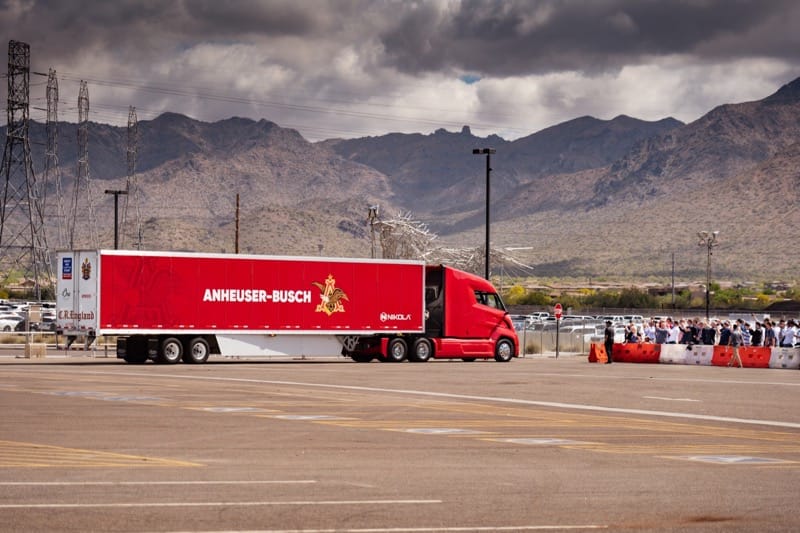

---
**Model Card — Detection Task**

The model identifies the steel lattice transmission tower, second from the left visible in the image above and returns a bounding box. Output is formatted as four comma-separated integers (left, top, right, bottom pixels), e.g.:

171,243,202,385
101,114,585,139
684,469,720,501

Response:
42,69,67,249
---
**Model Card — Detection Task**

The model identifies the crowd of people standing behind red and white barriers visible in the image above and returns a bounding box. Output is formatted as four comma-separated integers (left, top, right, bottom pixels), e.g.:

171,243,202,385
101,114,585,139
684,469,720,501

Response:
625,317,800,348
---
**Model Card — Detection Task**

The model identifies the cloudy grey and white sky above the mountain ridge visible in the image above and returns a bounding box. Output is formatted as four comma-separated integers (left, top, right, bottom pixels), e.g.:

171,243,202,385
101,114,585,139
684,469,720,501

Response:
0,0,800,140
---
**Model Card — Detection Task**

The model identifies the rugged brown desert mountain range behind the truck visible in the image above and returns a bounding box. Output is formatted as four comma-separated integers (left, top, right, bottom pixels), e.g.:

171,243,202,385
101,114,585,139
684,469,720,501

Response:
3,78,800,281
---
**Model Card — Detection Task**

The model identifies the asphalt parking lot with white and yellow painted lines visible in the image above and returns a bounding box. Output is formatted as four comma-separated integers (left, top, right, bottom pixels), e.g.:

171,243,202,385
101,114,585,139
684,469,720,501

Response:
0,355,800,532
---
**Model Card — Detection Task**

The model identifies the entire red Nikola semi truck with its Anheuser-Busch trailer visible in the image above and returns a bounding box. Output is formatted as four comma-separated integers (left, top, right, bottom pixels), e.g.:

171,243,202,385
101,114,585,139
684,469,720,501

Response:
56,250,519,363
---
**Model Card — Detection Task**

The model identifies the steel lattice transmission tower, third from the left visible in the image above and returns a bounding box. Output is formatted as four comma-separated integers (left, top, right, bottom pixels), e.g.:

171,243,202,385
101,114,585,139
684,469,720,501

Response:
67,80,97,249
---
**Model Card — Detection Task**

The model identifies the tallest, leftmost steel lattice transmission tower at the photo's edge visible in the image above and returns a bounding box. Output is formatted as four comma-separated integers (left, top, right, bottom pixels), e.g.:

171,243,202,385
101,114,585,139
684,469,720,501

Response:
0,41,53,300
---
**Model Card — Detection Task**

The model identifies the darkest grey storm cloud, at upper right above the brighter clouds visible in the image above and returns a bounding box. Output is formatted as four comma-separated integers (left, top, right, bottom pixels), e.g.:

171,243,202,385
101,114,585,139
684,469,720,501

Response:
382,0,800,76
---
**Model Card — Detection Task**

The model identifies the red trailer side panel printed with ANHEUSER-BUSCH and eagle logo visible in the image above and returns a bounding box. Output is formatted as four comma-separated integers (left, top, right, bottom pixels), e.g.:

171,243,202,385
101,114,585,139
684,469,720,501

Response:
99,251,425,334
